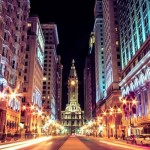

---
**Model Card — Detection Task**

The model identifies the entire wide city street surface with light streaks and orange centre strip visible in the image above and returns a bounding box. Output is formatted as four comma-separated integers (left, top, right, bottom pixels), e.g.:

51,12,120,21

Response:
0,136,149,150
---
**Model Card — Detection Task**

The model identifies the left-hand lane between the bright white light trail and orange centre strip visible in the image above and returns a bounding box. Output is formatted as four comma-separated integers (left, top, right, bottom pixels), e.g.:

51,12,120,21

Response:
20,136,68,150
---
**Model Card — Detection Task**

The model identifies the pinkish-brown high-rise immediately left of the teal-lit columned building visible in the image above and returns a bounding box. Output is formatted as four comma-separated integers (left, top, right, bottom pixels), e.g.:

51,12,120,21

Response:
103,0,121,137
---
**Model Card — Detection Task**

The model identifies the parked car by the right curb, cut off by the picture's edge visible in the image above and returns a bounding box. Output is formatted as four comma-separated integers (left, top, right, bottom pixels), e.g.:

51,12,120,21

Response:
126,135,150,145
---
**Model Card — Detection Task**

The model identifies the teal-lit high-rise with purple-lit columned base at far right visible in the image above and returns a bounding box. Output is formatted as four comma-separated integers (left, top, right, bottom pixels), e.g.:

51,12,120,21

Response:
118,0,150,135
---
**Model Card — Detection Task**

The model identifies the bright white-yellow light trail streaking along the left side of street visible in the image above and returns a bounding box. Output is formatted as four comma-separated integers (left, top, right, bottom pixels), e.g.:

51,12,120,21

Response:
0,137,52,150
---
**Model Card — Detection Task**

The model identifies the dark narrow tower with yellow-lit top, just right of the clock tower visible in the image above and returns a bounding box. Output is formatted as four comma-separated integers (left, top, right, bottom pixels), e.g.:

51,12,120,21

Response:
84,32,96,120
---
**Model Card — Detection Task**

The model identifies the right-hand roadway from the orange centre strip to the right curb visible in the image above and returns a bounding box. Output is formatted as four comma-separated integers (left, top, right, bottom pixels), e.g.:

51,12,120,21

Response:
79,137,149,150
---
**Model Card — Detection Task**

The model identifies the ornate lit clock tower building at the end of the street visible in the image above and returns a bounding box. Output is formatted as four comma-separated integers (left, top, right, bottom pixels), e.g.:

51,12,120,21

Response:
62,60,84,134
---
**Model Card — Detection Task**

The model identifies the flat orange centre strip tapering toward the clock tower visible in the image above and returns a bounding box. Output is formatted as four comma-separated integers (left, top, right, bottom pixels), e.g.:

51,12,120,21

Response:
59,136,90,150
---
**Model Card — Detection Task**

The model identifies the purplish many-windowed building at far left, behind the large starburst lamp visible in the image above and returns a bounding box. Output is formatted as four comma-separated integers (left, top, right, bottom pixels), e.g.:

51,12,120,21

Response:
0,0,30,137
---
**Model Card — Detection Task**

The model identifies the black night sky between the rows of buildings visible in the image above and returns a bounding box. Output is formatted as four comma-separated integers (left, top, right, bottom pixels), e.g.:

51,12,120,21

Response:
30,0,95,110
